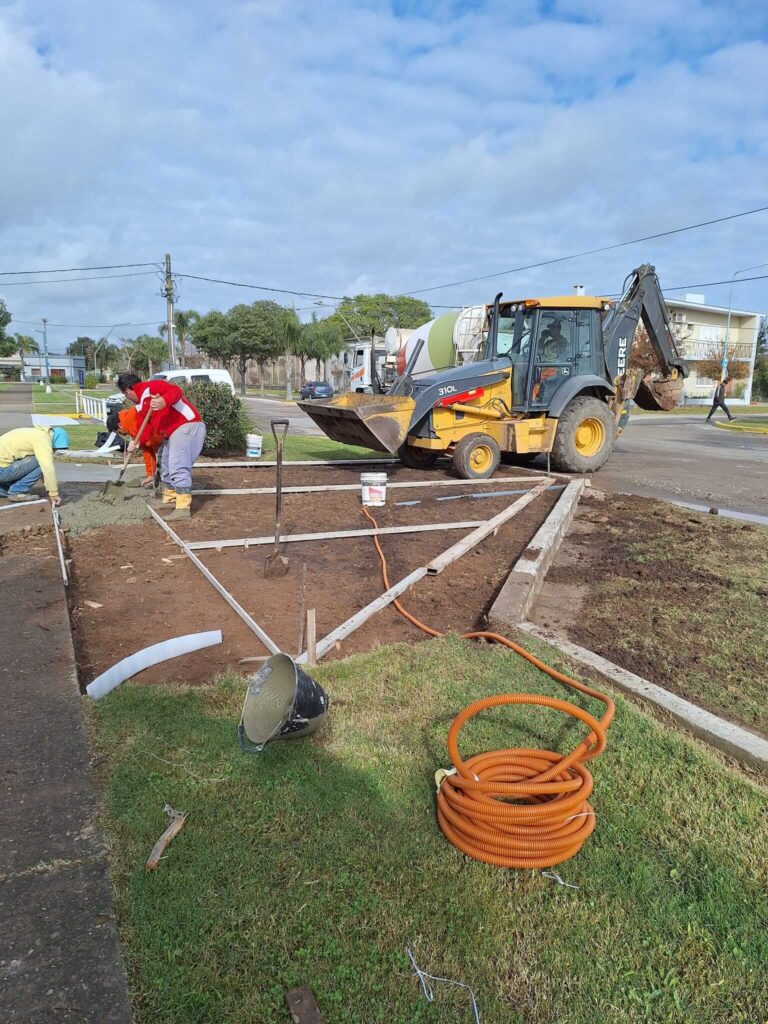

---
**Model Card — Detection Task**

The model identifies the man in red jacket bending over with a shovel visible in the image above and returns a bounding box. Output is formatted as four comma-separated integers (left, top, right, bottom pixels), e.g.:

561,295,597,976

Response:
118,374,206,522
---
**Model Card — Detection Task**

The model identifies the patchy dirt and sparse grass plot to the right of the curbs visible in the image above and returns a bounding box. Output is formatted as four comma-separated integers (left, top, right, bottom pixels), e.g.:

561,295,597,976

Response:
530,492,768,733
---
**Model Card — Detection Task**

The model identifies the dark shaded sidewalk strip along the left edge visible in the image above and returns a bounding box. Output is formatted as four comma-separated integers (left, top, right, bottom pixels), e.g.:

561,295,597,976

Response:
0,506,131,1024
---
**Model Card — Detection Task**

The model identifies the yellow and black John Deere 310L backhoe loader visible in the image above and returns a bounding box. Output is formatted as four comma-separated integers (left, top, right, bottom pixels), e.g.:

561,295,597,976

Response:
299,264,688,479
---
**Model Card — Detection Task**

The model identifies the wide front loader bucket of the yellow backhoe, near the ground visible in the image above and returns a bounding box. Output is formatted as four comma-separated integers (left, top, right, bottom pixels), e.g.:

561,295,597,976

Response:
297,392,416,452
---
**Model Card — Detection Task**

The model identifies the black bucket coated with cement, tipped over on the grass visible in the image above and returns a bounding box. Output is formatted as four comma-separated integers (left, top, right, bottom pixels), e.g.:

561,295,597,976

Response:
238,654,328,752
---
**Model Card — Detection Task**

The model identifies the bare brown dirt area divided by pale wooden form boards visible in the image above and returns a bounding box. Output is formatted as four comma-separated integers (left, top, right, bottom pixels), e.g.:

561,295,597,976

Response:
68,467,560,686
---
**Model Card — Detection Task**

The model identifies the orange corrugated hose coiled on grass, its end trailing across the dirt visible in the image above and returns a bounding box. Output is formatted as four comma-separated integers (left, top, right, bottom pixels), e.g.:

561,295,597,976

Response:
362,506,615,868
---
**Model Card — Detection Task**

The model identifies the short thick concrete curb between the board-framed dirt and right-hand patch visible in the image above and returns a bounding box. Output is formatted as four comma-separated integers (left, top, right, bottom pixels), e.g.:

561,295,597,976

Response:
488,479,587,630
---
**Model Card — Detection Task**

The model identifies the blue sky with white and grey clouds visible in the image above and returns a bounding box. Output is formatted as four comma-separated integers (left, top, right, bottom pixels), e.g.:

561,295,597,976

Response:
0,0,768,349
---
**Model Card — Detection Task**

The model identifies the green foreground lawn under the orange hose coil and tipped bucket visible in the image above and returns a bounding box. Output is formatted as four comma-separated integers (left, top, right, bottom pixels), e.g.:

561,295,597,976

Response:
88,638,768,1024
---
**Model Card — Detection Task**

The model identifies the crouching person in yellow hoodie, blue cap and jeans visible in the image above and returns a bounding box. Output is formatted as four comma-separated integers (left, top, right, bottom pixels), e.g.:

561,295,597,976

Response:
0,427,70,505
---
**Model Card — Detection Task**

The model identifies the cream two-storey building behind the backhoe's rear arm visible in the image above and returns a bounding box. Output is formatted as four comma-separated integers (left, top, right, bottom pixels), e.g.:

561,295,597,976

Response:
665,295,763,406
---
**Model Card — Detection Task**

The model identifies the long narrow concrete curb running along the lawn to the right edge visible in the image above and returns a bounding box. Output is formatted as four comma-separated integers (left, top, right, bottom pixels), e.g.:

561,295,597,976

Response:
517,623,768,769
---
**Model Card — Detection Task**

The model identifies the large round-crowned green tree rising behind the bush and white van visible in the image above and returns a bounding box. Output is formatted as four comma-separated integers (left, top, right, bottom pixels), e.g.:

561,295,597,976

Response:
191,299,288,394
